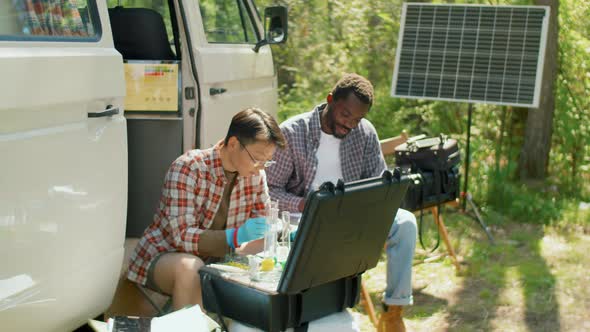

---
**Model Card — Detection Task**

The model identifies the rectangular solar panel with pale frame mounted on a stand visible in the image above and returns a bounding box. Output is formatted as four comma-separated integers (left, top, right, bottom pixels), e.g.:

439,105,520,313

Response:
391,3,549,107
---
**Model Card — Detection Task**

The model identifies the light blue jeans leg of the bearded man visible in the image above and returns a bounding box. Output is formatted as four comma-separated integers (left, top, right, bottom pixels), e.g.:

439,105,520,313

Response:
383,209,417,305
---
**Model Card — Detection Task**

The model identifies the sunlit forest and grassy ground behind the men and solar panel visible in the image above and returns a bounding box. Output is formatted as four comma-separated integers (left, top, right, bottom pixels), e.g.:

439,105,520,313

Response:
108,0,590,332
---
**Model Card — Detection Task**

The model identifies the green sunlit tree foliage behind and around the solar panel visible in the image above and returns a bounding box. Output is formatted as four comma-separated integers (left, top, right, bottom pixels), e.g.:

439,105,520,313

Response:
264,0,590,223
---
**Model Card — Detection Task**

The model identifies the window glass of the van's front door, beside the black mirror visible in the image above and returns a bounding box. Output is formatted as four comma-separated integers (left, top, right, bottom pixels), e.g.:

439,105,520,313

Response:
199,0,258,44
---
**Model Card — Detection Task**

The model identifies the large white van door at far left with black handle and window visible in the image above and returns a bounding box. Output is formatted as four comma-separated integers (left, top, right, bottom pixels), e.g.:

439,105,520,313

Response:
0,0,127,331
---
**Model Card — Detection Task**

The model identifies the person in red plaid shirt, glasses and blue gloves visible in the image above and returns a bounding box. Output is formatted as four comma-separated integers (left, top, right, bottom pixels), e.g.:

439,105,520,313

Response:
127,108,285,310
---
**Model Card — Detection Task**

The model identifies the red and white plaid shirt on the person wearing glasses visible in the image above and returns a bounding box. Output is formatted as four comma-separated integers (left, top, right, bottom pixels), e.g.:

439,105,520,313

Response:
127,144,268,285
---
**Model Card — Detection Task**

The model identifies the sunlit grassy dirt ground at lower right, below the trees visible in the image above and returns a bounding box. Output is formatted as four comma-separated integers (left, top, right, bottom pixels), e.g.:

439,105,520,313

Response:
354,213,590,332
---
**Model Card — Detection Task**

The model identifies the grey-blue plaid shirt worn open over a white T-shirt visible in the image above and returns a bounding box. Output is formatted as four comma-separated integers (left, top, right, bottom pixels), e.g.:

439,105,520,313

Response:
266,104,387,211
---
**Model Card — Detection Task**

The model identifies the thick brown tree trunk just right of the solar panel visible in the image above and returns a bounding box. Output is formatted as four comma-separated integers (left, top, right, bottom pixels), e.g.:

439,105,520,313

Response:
518,0,559,181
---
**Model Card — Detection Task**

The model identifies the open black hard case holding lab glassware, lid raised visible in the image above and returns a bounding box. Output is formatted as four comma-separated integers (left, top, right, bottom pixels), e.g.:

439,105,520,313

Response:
199,170,410,331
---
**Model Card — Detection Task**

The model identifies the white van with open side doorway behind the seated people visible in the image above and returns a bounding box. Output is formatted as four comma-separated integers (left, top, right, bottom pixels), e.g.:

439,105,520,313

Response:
0,0,287,331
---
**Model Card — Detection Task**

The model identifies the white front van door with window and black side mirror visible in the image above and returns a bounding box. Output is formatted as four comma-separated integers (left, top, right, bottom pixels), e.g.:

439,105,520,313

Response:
180,0,286,148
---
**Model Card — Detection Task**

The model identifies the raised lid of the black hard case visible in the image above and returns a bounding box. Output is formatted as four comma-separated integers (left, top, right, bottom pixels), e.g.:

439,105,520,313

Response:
278,170,410,294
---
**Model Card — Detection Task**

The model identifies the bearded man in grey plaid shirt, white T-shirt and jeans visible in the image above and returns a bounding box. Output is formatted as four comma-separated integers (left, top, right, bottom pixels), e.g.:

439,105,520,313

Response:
267,74,416,331
